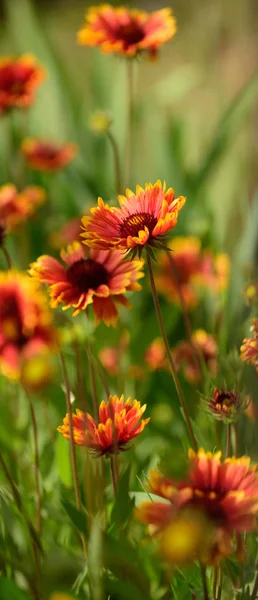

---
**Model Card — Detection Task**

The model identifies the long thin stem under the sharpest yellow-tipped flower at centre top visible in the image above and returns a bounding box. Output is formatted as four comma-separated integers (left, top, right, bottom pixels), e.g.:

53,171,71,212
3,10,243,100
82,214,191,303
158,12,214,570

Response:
147,254,197,451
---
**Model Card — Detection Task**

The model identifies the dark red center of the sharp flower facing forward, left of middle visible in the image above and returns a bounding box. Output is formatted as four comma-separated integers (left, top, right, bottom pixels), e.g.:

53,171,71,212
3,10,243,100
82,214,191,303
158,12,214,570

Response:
66,258,109,292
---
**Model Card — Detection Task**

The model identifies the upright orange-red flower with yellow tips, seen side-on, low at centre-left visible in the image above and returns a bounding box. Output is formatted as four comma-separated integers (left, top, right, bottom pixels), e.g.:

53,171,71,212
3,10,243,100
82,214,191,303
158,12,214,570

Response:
57,395,150,456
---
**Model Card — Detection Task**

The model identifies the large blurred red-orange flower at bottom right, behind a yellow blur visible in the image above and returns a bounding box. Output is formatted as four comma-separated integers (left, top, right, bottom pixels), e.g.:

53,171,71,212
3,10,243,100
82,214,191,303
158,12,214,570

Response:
137,448,258,563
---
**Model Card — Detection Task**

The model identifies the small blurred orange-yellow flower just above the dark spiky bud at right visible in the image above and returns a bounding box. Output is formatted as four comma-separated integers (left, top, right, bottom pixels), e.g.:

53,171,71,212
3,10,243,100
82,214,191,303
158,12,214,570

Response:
172,329,218,383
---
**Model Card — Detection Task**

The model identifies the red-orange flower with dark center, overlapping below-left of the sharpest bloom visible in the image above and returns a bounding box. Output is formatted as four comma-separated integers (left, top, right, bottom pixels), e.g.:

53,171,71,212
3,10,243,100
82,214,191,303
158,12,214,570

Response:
29,242,143,325
